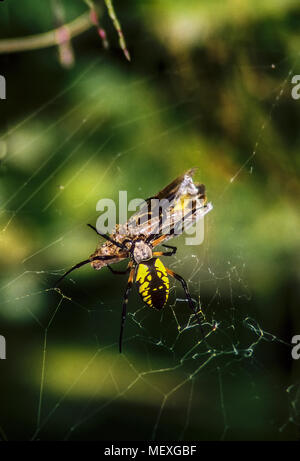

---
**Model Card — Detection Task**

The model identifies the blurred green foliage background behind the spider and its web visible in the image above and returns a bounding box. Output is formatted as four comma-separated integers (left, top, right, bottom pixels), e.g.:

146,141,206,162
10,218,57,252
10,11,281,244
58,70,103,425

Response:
0,0,300,440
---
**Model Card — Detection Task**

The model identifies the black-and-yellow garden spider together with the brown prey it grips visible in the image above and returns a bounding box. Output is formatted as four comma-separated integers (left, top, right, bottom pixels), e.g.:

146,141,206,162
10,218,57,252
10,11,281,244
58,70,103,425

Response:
57,169,212,352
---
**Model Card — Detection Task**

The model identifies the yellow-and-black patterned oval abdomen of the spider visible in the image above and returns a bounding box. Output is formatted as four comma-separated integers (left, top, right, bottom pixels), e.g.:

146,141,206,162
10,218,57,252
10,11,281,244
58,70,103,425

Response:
136,258,170,310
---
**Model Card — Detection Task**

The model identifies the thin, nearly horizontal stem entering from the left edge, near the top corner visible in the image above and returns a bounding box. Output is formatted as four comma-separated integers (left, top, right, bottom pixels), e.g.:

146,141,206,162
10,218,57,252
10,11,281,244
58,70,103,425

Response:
0,12,93,54
